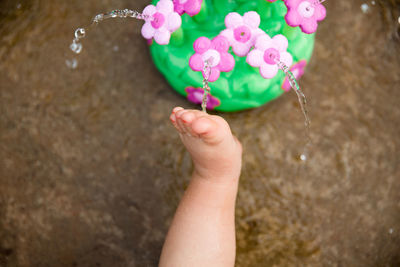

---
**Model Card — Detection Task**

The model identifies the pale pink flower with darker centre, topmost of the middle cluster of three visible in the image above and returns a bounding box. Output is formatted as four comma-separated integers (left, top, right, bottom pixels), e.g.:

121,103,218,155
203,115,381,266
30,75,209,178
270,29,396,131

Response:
221,11,264,57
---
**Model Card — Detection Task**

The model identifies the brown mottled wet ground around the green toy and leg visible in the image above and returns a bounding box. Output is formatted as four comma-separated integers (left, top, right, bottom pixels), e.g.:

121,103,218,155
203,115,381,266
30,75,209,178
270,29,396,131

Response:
0,0,400,266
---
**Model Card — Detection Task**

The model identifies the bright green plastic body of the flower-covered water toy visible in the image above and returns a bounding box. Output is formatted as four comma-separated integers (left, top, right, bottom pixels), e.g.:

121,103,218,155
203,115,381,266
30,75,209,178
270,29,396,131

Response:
150,0,314,112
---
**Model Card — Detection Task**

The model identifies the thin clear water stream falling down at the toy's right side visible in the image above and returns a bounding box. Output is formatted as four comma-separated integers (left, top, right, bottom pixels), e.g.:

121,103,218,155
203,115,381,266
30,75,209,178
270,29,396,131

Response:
276,60,311,161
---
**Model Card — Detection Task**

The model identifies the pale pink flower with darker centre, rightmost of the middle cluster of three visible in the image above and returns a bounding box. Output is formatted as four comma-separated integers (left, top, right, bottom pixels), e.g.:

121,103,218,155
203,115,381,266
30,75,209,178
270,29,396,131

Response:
246,34,293,79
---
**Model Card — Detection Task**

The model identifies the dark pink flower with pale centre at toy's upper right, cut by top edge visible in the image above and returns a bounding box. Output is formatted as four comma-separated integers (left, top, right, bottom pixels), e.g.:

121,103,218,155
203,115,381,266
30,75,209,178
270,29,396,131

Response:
285,0,326,33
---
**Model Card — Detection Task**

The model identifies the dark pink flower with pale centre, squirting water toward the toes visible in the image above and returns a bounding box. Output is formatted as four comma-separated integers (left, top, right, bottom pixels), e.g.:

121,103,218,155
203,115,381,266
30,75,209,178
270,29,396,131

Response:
189,35,235,82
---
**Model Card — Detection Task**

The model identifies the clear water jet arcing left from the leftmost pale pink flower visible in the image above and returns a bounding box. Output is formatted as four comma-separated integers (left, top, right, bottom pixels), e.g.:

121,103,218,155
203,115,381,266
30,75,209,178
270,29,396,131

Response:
69,9,153,54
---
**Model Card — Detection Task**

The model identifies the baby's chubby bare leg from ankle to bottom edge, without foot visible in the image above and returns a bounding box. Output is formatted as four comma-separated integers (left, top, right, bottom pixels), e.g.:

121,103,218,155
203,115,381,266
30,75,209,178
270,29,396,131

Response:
159,174,239,267
